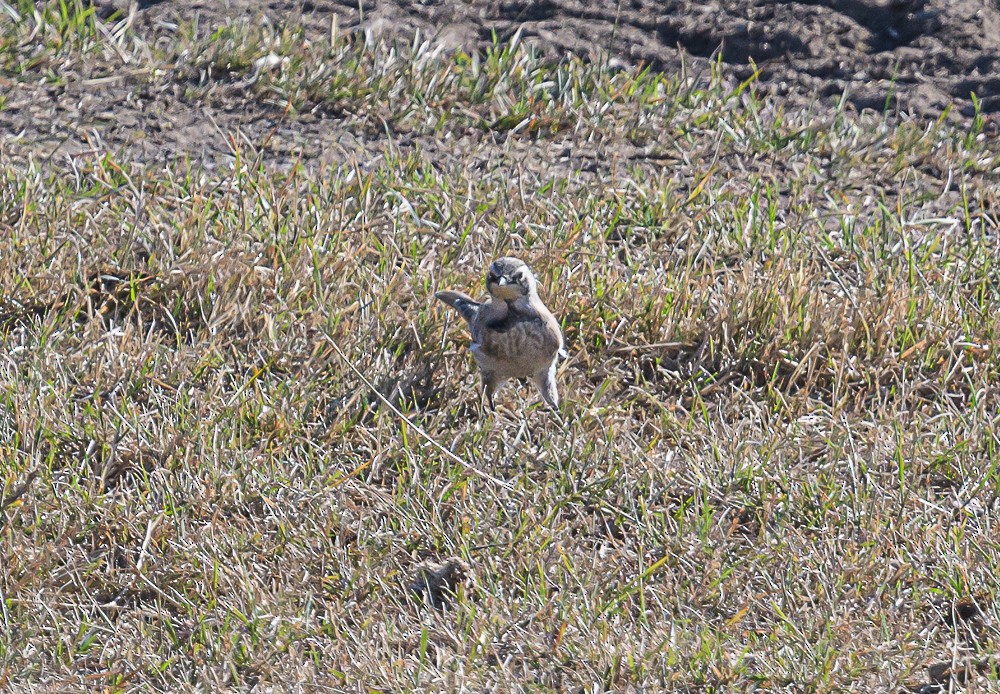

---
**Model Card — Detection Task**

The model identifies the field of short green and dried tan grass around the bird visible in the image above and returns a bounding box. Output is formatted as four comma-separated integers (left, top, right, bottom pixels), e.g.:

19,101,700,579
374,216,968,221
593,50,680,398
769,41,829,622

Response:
0,3,1000,693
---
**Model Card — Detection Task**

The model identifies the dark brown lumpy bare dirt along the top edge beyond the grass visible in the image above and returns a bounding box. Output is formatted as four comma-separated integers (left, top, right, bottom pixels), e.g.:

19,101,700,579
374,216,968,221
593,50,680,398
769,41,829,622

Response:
131,0,1000,118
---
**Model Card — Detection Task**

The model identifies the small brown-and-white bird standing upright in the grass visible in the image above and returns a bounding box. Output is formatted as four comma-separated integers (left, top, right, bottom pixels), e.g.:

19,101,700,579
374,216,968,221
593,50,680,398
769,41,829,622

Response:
434,258,563,410
